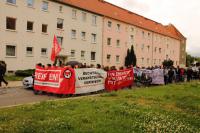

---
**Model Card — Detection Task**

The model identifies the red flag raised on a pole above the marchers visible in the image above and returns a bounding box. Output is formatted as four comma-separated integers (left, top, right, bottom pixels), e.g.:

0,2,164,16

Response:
51,35,61,62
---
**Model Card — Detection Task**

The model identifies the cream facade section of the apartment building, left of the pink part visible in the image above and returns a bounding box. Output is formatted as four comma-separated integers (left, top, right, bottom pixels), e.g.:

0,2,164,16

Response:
0,0,102,71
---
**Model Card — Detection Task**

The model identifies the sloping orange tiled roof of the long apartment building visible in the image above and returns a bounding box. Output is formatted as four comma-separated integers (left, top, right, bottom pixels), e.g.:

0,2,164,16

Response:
56,0,185,40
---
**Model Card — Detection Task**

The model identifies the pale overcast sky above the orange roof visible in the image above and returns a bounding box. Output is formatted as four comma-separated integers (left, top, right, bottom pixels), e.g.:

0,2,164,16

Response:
105,0,200,57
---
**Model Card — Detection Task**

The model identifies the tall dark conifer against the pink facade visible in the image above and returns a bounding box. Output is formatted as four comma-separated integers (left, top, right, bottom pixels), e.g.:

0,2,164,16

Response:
125,45,137,66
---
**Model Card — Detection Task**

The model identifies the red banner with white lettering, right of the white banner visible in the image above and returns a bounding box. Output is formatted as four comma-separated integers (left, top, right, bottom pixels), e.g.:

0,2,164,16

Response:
105,68,134,91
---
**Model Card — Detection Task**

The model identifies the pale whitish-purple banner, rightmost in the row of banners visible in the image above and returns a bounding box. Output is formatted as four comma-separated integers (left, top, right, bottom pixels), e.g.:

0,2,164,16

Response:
151,69,165,85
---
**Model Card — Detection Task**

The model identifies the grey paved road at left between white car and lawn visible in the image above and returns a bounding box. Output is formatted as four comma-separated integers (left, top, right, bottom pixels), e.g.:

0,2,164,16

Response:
0,87,58,108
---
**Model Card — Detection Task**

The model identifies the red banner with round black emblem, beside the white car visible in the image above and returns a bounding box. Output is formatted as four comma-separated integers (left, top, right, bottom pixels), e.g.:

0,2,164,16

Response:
34,66,75,94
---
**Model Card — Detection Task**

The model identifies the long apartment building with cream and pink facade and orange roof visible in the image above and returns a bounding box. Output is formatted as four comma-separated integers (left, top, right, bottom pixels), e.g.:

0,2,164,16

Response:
0,0,186,71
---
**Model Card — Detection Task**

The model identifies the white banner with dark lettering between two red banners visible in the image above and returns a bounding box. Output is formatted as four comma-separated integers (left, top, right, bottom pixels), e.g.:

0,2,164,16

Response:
75,68,107,94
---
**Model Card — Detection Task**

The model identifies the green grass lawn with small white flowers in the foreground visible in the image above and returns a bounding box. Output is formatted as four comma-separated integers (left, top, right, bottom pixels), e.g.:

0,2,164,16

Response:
0,82,200,133
